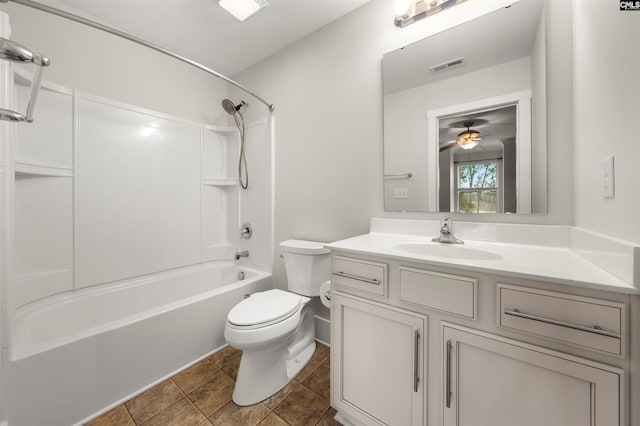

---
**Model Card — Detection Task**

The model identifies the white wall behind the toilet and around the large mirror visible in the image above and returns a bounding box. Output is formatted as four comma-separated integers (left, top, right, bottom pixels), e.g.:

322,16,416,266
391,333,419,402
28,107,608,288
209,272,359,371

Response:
235,0,573,292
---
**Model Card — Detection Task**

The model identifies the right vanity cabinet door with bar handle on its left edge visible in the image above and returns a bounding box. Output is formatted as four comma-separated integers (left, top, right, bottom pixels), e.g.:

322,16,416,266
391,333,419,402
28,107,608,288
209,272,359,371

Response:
442,324,624,426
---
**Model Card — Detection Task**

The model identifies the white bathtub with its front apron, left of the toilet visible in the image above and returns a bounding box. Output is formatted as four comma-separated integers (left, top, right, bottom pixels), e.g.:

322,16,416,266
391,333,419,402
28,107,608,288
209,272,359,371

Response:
3,262,273,426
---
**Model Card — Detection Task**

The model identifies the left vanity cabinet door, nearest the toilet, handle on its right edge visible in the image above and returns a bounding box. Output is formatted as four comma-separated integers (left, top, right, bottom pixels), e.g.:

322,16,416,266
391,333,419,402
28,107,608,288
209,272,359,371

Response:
331,293,427,425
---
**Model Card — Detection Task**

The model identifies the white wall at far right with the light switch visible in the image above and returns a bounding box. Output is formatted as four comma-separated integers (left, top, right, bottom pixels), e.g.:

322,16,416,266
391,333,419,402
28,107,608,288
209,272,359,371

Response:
574,0,640,243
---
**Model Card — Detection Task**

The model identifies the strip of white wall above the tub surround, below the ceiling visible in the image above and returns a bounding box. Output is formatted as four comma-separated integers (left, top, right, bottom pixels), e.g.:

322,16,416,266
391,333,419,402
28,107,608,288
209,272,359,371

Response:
0,2,227,123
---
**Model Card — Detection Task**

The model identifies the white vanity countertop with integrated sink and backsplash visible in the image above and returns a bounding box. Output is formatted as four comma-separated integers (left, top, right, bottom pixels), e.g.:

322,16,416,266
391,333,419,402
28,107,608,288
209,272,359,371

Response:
326,218,640,294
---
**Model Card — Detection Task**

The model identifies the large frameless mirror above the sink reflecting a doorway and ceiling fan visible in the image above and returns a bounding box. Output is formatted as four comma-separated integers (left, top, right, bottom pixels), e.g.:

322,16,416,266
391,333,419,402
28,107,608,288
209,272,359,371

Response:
382,0,547,214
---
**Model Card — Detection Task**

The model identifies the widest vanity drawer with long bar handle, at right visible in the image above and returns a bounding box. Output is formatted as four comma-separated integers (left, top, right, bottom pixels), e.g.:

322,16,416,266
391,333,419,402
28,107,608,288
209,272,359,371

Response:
497,283,626,356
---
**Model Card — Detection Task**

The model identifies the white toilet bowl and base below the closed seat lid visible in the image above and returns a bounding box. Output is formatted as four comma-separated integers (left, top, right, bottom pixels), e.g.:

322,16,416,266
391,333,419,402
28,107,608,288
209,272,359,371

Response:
233,306,316,406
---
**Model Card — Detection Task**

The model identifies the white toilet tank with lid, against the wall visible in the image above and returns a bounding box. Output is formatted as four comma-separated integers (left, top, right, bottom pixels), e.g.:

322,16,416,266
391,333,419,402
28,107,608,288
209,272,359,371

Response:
280,240,331,297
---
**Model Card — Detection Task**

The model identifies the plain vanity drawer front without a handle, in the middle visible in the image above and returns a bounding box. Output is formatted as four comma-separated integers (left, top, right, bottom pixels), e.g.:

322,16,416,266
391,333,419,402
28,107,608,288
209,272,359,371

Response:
398,266,478,319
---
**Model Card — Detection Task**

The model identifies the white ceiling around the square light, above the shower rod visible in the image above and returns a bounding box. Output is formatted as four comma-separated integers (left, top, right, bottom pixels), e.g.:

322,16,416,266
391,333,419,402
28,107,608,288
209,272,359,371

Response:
46,0,369,77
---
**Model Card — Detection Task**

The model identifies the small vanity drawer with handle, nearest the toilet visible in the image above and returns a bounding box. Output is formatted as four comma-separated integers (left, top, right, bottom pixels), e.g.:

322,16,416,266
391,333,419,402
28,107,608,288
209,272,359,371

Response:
332,256,387,297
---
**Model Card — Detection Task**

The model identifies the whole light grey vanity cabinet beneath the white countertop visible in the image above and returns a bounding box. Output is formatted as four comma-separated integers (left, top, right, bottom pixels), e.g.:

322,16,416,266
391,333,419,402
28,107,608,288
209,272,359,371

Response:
331,249,636,426
